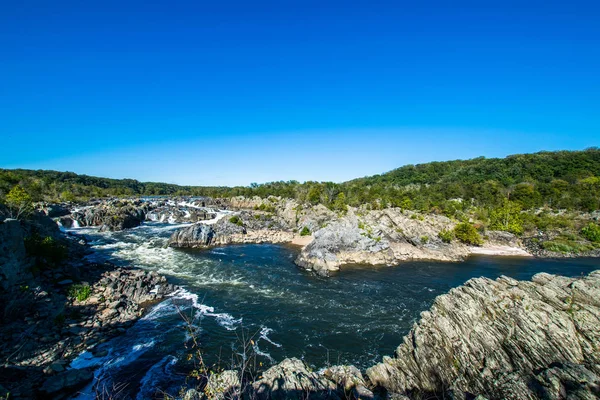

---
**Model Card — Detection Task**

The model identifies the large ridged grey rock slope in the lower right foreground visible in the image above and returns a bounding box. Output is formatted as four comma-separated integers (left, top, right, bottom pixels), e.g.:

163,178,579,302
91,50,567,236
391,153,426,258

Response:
367,271,600,399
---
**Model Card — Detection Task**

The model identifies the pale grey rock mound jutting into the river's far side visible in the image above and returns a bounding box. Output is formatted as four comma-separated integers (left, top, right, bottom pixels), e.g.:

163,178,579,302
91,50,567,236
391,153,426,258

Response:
296,208,470,275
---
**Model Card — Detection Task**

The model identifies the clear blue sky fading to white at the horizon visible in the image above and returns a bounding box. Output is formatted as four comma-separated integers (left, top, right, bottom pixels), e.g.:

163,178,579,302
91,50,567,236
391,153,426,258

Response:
0,0,600,185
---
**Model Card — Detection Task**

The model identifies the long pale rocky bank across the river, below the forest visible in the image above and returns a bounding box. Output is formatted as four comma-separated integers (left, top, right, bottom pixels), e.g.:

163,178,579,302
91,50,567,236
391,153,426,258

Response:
169,197,600,275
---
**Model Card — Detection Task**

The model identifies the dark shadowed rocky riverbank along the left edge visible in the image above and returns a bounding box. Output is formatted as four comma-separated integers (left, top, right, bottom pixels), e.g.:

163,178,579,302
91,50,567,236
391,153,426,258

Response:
0,215,176,399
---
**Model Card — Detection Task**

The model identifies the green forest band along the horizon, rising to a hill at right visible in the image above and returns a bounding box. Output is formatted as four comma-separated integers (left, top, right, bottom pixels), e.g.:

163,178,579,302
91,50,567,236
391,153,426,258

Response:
0,148,600,215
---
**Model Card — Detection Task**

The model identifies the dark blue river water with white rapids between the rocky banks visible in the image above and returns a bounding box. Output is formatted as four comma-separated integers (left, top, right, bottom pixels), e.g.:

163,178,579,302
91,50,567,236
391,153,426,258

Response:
63,223,600,399
